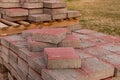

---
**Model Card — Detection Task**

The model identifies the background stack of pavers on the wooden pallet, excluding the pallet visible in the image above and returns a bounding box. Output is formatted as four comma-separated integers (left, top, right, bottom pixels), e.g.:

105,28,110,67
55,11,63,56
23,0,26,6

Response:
0,0,80,22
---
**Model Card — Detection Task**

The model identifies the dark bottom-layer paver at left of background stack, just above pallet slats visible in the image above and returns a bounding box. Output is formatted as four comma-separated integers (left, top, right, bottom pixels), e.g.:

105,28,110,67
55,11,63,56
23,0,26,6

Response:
3,15,28,21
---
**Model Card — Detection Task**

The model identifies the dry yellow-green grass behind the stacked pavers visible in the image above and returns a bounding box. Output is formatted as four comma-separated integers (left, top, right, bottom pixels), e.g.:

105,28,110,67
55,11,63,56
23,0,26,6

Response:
66,0,120,36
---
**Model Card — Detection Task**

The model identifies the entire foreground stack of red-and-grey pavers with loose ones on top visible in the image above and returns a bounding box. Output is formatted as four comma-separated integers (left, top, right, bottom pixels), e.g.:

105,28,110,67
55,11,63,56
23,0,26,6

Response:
1,28,120,80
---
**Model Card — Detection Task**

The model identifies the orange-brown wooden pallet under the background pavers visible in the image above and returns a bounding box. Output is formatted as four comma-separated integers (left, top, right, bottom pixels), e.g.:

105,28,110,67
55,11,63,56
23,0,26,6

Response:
0,18,79,36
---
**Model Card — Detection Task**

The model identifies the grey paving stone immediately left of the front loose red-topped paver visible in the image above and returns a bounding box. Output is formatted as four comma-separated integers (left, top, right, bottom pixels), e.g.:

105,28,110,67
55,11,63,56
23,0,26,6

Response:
28,52,46,74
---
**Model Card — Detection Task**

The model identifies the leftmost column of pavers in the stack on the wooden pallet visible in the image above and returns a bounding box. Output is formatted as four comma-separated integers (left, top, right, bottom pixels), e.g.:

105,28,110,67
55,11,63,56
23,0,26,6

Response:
0,0,28,21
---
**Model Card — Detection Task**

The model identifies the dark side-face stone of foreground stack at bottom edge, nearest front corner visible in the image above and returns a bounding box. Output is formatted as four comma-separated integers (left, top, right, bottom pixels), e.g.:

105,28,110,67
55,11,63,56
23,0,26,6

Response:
29,68,43,80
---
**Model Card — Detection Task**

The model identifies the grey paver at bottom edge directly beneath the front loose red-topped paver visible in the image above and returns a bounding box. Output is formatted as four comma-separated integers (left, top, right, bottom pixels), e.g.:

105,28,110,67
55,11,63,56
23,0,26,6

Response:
42,69,90,80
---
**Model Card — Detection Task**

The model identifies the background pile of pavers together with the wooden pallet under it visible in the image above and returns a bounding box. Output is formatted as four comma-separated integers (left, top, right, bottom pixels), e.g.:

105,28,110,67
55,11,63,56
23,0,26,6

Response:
0,0,80,36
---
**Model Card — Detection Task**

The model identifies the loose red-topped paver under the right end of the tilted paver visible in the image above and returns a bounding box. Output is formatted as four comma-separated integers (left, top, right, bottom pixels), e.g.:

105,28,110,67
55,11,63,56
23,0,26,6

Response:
58,35,81,48
